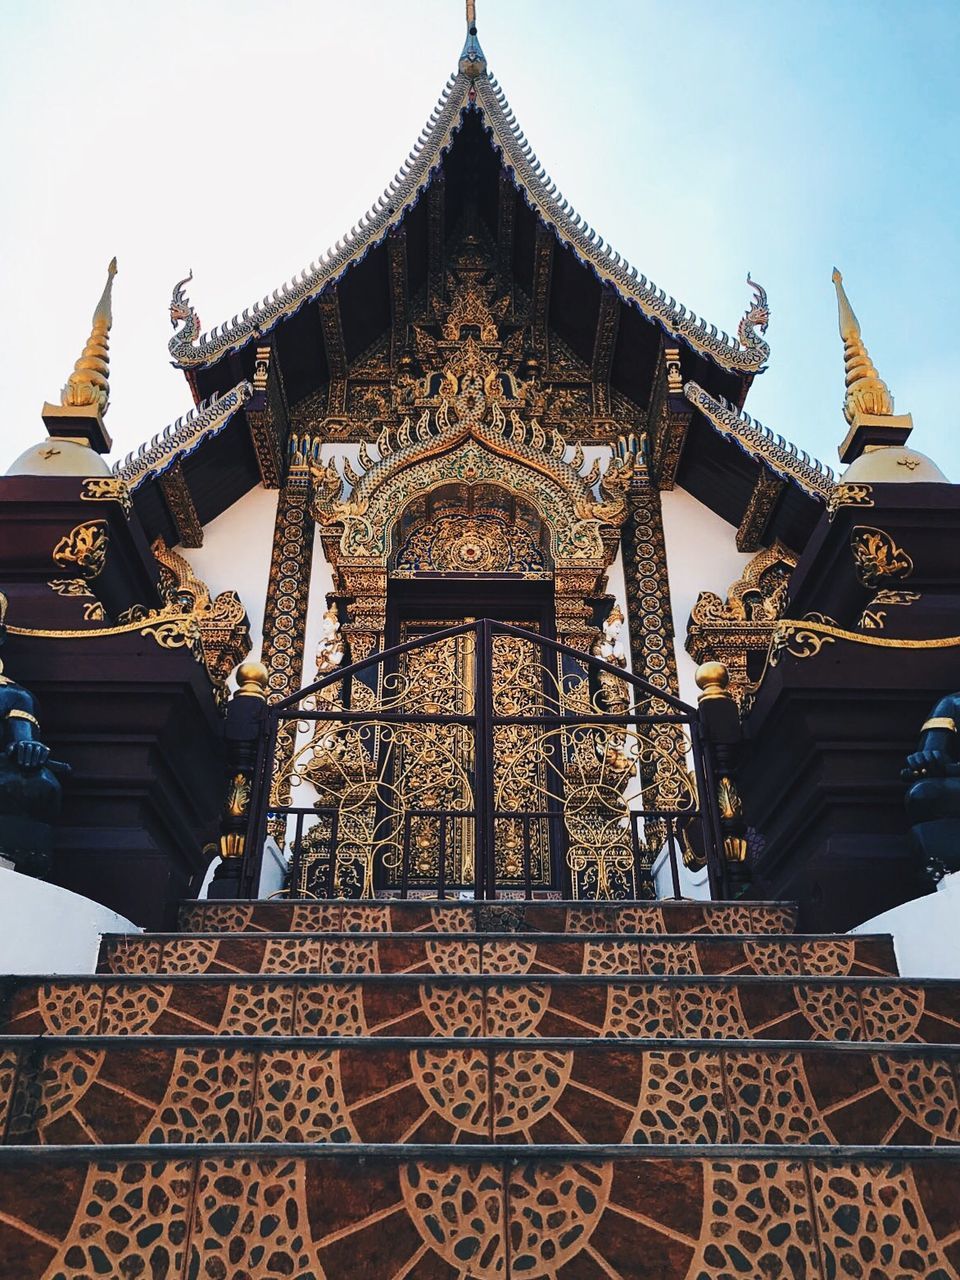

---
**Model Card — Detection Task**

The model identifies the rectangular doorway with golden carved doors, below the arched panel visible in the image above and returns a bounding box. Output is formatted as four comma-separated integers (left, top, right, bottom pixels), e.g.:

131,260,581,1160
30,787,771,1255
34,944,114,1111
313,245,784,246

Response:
379,576,563,896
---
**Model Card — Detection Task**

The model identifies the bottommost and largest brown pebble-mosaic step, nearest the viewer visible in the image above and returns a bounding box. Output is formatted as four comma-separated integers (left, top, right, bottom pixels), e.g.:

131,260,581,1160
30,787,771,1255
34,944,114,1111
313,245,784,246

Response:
0,1146,960,1280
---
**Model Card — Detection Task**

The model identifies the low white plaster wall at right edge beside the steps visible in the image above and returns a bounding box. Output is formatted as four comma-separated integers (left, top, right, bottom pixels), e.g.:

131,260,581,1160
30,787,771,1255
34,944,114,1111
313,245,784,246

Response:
850,872,960,978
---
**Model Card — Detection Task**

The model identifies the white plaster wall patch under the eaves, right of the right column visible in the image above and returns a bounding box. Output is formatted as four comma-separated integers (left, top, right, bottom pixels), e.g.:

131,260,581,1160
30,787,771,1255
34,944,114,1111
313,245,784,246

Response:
660,489,753,705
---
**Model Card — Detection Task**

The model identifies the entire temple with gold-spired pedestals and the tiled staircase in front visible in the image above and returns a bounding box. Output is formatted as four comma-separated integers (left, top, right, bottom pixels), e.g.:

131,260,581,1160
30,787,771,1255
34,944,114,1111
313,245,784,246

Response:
0,0,960,1280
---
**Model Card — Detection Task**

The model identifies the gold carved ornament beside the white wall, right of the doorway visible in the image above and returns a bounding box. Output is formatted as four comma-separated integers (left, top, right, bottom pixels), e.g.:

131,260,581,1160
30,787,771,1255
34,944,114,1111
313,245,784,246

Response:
686,543,796,709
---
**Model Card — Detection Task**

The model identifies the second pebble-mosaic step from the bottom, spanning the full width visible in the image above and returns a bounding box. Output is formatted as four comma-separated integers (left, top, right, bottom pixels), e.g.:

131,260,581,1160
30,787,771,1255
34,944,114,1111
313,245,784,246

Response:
0,1037,960,1146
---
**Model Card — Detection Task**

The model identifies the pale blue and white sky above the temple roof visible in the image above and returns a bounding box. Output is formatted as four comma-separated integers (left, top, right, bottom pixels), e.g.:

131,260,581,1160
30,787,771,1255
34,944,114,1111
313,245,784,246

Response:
0,0,960,480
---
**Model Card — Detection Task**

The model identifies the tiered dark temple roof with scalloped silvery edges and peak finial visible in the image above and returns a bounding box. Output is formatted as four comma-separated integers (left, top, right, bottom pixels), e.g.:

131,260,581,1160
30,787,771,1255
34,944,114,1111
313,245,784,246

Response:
115,3,833,550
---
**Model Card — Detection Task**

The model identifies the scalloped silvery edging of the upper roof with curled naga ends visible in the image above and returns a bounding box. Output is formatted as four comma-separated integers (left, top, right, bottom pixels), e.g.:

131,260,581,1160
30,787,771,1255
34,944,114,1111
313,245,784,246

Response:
169,59,769,376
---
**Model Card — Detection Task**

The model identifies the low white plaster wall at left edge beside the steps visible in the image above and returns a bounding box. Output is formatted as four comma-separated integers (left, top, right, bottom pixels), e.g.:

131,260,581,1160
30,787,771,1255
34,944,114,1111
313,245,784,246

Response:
0,867,141,974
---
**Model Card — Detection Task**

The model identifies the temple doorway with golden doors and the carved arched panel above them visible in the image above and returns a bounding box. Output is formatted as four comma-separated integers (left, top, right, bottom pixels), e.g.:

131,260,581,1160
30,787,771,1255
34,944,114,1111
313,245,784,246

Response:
380,481,563,895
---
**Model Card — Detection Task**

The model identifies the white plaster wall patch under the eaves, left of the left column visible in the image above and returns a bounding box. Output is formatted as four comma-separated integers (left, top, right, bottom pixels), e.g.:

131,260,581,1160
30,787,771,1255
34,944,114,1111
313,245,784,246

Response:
175,485,279,680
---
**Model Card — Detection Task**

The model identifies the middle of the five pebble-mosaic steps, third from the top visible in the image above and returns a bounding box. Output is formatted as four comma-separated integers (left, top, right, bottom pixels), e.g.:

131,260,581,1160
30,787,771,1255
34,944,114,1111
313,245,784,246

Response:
7,974,960,1044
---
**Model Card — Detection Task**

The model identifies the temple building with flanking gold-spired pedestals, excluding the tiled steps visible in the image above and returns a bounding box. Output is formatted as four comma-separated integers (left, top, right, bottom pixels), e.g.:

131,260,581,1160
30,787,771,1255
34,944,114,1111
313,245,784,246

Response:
0,5,960,927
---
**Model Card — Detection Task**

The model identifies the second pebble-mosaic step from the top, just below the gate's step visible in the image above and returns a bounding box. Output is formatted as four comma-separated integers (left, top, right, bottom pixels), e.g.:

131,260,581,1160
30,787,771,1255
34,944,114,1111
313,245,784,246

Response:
97,933,897,977
